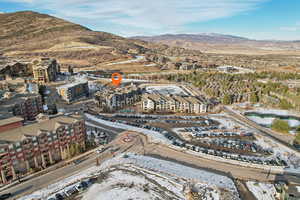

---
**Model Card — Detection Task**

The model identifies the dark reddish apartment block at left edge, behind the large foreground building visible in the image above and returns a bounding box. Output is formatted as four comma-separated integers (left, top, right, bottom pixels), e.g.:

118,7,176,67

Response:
0,93,43,120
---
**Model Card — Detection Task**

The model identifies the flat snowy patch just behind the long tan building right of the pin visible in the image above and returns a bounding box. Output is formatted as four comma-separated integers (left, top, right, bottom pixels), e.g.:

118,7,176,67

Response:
146,85,188,95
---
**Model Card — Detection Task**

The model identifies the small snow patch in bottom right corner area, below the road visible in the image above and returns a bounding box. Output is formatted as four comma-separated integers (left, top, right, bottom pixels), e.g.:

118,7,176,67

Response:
246,181,276,200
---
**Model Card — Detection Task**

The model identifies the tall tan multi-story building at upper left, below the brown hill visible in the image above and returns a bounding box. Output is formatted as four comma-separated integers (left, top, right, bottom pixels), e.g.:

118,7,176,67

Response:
31,58,60,84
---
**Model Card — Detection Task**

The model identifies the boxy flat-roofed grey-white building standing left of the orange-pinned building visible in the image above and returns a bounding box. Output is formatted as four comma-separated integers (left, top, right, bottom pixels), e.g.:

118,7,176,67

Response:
57,81,89,103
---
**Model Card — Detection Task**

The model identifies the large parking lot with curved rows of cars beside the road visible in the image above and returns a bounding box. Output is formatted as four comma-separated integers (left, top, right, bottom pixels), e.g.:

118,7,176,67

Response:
101,114,287,166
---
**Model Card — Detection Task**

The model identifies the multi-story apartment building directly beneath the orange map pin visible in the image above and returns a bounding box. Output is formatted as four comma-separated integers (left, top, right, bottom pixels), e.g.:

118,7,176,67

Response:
95,85,143,111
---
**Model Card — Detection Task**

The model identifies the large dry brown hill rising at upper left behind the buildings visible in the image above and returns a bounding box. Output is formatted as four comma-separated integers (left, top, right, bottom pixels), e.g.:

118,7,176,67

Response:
0,11,152,70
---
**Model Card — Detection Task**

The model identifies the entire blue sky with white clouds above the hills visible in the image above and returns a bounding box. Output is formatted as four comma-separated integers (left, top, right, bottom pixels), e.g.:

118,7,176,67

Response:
0,0,300,40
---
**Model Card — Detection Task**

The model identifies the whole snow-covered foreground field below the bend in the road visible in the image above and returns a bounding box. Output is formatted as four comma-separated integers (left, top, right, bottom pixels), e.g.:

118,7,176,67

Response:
19,153,239,200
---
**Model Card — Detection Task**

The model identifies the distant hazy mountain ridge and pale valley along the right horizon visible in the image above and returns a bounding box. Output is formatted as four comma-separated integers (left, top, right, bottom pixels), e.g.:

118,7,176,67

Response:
133,33,300,55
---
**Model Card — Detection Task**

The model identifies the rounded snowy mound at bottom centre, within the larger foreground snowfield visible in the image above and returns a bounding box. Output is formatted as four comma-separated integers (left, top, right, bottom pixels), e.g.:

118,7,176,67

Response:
82,165,185,200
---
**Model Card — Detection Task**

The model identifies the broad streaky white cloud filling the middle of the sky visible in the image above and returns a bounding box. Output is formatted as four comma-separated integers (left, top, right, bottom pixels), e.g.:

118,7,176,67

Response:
0,0,267,34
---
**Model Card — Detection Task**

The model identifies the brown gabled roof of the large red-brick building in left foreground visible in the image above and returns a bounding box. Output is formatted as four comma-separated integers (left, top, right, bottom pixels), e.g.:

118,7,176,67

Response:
0,115,82,143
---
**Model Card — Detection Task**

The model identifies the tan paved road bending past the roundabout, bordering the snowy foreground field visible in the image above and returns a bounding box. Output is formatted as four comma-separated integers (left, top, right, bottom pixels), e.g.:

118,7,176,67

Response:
2,126,288,197
